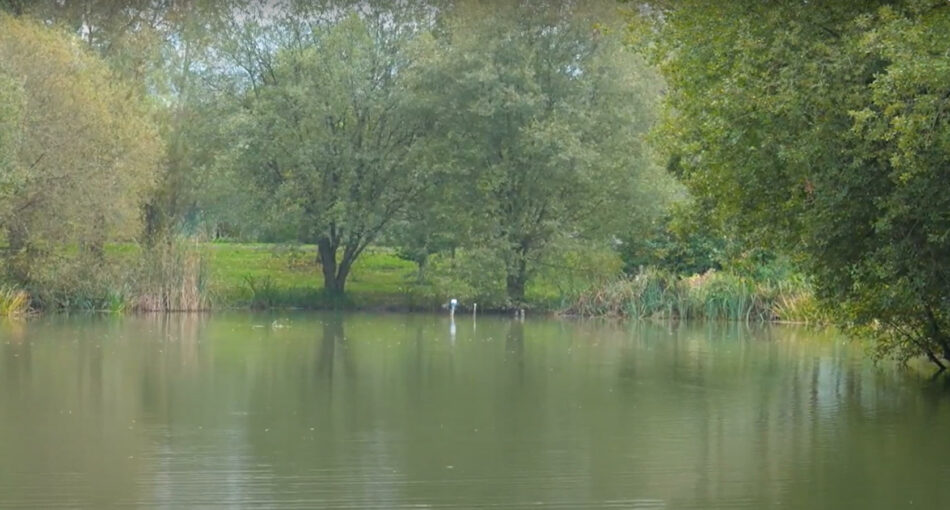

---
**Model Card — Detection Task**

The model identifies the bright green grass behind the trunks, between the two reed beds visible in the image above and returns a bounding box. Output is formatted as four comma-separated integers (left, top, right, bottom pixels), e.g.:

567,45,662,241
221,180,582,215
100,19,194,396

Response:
205,243,620,311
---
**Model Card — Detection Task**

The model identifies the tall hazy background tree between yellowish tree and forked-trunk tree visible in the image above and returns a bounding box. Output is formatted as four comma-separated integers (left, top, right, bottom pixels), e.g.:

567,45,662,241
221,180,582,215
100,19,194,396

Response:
143,0,242,245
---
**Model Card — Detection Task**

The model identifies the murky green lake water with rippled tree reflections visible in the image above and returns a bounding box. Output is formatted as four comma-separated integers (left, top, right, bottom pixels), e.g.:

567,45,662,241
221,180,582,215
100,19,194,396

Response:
0,314,950,509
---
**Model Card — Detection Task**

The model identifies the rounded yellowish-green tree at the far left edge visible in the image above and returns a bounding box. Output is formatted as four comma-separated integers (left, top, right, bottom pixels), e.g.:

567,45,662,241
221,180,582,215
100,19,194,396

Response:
0,14,161,283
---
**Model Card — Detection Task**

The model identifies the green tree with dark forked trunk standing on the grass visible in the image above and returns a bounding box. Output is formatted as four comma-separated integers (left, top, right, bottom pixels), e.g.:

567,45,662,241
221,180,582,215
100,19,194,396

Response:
234,10,427,297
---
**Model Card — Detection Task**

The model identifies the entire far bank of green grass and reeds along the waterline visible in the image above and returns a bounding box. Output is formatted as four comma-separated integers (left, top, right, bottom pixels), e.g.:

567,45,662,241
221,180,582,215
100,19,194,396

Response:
0,243,826,323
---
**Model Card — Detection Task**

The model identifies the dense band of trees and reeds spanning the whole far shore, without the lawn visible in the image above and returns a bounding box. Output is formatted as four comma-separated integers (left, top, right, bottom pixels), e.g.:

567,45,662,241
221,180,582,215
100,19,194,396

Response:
0,0,950,366
